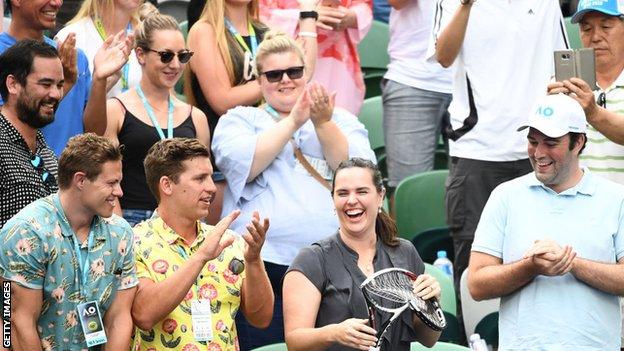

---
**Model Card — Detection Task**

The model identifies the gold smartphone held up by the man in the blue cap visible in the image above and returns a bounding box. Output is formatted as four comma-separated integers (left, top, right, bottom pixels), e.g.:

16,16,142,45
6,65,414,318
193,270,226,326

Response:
555,48,598,90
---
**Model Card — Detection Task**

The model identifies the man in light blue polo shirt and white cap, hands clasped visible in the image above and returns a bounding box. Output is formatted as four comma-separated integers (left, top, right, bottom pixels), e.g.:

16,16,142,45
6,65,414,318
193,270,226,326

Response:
468,95,624,350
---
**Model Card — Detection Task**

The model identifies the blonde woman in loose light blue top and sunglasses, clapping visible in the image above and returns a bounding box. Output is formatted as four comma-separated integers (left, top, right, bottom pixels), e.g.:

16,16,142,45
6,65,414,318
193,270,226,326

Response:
212,32,375,350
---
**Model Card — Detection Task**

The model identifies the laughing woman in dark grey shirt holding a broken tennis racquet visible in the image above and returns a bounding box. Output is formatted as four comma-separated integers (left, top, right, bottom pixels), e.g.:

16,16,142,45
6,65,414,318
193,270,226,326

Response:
283,158,440,351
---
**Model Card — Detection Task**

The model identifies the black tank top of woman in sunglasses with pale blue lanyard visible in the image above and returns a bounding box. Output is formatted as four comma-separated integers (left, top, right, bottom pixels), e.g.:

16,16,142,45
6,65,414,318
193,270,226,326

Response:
114,98,197,211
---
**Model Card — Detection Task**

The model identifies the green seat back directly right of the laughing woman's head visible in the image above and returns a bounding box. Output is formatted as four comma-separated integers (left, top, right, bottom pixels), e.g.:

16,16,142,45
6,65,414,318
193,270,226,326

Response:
393,170,448,241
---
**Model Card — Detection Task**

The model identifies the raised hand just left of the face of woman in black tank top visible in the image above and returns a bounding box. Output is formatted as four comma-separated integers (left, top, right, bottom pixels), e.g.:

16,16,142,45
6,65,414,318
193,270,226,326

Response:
93,30,134,79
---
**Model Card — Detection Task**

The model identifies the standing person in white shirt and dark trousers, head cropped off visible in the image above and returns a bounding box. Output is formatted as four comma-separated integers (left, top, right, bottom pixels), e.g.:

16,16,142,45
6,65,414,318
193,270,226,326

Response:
429,0,566,342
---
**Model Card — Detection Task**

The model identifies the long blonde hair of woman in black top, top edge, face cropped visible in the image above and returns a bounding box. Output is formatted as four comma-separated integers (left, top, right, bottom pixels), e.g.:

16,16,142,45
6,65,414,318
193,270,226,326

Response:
197,0,264,85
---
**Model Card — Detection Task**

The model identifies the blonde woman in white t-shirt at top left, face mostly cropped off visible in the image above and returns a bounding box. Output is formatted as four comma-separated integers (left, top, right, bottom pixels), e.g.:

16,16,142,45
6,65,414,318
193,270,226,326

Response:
56,0,143,98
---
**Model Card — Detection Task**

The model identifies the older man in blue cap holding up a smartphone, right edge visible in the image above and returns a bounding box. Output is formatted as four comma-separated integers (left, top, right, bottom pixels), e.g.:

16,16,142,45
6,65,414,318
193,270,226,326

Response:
548,0,624,184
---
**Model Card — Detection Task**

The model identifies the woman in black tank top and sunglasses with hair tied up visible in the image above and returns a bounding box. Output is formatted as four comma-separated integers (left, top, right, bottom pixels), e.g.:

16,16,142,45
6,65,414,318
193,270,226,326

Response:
105,14,210,225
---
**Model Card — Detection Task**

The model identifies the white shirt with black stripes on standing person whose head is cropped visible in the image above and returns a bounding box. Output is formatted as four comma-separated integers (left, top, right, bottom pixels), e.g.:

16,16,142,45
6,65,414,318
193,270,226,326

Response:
428,0,567,162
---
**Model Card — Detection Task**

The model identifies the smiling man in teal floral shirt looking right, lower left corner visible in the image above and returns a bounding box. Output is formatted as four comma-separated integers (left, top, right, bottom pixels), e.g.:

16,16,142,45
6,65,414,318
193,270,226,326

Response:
0,133,137,351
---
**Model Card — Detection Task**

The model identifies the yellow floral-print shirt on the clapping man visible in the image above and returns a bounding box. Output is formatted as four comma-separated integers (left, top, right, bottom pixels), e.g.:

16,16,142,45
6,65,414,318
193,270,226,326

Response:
132,216,245,351
